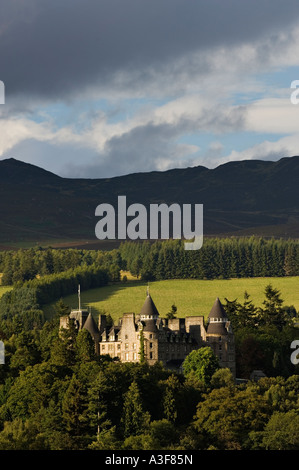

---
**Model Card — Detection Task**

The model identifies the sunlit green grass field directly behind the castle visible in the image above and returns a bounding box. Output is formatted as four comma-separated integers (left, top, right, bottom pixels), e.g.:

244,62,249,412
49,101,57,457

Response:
45,277,299,321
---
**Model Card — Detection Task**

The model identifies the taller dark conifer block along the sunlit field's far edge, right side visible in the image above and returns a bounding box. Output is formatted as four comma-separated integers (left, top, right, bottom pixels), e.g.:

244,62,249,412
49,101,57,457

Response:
119,237,299,280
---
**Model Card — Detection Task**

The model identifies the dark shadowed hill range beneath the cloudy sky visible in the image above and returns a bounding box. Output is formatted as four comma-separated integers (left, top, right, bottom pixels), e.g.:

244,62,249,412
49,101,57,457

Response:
0,156,299,248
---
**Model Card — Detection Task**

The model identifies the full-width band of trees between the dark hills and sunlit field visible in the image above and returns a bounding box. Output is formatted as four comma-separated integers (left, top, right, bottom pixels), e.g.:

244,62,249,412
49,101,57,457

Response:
0,237,299,285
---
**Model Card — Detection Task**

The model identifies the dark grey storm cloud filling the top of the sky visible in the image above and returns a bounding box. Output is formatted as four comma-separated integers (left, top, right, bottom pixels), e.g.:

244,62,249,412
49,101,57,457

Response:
0,0,298,99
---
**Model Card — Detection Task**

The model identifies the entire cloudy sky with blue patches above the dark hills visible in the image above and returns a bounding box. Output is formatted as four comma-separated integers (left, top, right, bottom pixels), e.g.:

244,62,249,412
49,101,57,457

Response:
0,0,299,178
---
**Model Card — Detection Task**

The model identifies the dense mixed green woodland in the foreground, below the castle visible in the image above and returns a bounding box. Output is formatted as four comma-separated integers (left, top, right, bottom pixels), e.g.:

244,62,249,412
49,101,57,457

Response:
0,302,299,450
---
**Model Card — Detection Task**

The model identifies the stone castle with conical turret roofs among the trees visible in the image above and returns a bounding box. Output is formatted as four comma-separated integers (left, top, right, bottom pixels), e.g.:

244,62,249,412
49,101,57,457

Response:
60,291,236,377
